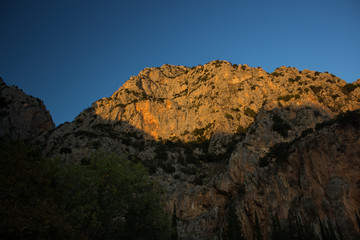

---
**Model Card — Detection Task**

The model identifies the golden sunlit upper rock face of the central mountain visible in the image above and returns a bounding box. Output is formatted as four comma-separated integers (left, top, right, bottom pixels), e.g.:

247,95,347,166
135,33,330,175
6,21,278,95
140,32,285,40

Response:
41,61,360,160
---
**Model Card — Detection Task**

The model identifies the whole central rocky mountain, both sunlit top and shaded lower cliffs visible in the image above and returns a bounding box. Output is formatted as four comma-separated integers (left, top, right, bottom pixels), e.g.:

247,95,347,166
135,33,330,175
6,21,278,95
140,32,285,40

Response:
37,61,360,239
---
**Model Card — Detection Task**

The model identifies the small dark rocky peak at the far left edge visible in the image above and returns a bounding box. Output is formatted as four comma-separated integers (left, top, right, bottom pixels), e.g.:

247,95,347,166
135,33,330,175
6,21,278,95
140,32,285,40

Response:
0,78,55,139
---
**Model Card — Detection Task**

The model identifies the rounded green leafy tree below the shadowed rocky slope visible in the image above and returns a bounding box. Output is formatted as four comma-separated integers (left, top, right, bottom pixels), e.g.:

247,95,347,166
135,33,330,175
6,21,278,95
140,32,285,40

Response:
59,154,170,239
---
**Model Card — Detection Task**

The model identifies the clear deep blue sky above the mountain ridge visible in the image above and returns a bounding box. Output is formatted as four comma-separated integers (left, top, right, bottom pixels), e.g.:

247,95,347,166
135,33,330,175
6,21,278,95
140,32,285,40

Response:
0,0,360,125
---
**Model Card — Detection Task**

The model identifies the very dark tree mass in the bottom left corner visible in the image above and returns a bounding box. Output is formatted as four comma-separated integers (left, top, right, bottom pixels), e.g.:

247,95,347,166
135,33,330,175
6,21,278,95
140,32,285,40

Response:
0,139,74,239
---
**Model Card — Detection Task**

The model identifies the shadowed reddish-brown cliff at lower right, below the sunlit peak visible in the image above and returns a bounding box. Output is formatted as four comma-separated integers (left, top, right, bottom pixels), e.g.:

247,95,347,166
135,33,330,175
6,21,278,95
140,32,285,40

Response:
172,110,360,239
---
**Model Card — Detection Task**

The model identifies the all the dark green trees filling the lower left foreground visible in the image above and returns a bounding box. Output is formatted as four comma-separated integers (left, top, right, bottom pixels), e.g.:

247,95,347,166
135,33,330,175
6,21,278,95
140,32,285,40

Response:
0,140,170,239
